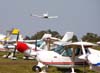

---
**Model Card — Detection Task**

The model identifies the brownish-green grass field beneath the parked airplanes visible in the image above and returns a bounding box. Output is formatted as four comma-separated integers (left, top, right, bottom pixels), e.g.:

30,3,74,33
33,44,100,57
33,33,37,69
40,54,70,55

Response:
0,52,97,73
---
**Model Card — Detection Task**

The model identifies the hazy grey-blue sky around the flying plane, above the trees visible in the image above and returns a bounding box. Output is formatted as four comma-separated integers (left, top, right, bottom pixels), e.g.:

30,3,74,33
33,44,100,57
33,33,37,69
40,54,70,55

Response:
0,0,100,37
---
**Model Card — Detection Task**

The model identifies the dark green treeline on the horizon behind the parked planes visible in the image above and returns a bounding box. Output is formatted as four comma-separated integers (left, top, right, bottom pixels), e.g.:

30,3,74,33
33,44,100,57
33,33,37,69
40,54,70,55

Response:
24,29,100,42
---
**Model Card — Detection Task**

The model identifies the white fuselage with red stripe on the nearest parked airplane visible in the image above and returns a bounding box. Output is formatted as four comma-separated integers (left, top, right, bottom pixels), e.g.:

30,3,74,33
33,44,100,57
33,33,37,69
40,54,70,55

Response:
37,51,84,68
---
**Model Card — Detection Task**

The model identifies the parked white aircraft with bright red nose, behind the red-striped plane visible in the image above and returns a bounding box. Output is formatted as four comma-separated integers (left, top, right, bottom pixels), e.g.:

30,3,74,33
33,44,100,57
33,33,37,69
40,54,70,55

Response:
14,32,74,56
